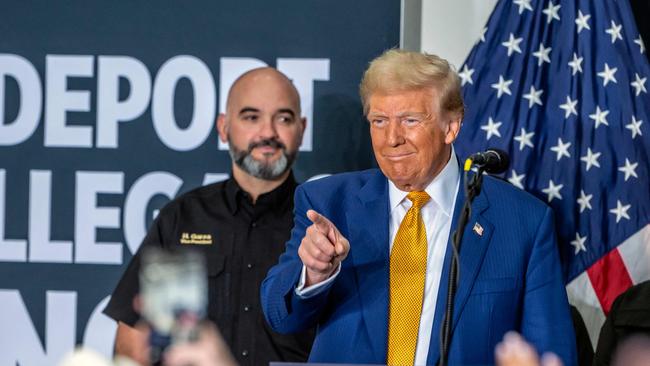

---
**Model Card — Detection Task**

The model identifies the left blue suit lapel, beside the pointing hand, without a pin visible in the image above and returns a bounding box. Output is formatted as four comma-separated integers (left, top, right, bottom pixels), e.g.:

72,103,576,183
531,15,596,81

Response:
346,171,389,362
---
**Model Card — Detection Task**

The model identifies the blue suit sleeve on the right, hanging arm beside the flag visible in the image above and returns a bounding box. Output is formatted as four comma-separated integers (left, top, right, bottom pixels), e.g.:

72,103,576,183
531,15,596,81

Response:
521,208,576,366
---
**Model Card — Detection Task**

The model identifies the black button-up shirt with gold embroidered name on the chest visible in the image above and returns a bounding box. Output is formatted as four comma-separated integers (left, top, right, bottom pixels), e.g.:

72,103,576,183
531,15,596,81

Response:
104,175,313,365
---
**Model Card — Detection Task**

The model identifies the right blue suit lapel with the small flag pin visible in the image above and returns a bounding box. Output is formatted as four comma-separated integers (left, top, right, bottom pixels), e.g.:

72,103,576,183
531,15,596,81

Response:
427,171,494,365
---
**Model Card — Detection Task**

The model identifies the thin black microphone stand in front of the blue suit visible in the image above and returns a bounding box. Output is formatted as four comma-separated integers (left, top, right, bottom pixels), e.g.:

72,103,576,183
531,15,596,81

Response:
438,164,484,366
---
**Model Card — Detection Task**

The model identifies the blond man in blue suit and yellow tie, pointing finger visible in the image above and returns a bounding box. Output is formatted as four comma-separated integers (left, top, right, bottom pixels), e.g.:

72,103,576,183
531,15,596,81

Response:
262,50,575,365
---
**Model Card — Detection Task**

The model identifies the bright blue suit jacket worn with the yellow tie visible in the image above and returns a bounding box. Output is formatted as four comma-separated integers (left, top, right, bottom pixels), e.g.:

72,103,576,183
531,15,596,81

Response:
261,170,576,365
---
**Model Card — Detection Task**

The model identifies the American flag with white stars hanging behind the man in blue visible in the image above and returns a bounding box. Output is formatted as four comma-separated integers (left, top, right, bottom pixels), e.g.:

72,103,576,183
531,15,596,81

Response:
456,0,650,344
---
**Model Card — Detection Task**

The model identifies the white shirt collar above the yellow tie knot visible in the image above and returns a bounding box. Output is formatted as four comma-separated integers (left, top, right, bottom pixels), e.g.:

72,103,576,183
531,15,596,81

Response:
388,145,460,217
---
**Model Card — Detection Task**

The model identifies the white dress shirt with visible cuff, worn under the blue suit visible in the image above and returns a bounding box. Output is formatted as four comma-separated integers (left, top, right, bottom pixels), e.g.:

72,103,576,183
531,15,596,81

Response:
296,152,460,365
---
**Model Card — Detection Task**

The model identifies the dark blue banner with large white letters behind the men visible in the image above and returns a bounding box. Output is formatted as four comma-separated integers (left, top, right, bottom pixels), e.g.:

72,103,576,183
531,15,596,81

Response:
0,0,400,365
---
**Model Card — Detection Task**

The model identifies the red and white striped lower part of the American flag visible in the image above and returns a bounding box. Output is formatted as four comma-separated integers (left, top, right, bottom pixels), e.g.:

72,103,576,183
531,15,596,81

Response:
567,224,650,349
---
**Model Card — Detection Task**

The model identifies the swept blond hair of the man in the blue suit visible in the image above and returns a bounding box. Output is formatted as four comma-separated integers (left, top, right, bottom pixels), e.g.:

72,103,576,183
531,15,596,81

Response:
359,49,465,117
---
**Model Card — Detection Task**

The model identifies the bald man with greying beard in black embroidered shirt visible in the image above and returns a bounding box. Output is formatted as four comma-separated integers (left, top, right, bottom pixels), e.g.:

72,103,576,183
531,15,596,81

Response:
104,67,313,365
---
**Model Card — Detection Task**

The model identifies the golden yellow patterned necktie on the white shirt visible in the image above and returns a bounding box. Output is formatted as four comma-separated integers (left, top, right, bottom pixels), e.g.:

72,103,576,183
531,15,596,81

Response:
386,191,430,366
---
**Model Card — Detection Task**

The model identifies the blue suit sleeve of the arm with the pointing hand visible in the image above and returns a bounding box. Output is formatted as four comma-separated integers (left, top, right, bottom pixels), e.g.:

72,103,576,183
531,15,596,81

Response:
260,186,331,333
